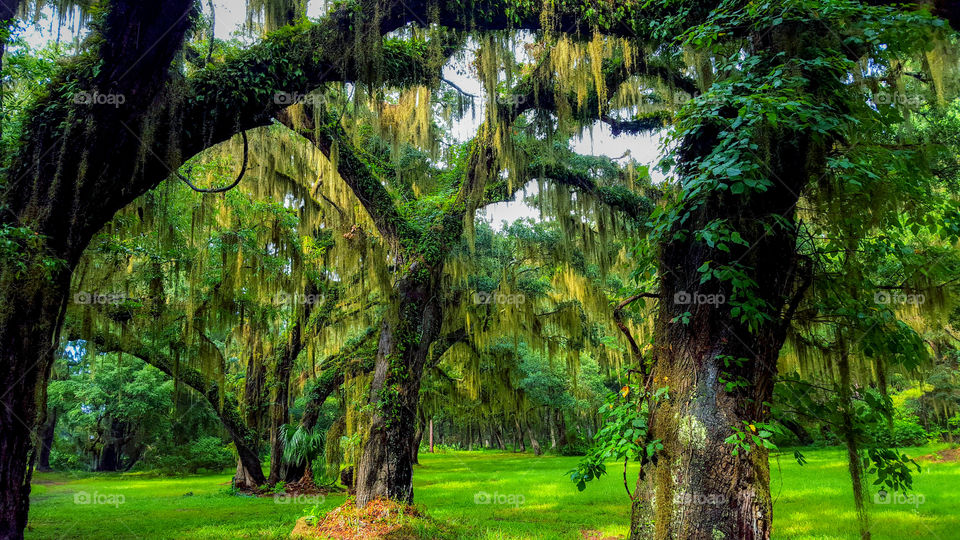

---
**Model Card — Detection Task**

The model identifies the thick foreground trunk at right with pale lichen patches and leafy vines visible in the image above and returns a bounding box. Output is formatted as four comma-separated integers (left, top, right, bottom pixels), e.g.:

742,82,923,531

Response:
631,123,815,540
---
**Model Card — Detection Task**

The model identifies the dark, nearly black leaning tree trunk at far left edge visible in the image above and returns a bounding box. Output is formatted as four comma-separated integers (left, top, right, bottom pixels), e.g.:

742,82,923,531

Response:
0,0,193,538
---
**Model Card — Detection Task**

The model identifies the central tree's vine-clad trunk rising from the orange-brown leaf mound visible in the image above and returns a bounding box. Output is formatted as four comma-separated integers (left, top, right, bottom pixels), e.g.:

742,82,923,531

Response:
356,263,441,506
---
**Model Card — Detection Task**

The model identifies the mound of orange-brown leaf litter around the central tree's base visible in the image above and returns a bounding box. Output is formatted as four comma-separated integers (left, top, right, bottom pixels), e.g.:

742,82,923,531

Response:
290,497,438,540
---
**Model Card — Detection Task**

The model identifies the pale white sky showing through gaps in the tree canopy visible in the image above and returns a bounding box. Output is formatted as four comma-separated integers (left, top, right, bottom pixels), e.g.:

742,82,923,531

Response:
16,0,664,229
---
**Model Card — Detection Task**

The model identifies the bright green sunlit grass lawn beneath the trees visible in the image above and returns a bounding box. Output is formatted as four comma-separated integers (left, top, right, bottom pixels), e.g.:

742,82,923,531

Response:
26,445,960,540
